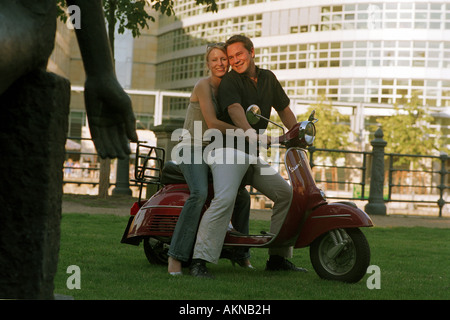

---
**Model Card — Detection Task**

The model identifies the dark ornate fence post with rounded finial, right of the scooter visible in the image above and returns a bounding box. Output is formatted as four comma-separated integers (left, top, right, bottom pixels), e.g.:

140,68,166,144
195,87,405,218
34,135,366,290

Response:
365,127,387,215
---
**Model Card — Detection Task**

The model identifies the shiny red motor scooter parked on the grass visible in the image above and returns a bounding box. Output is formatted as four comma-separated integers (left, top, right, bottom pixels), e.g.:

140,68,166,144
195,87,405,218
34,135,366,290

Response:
122,105,373,282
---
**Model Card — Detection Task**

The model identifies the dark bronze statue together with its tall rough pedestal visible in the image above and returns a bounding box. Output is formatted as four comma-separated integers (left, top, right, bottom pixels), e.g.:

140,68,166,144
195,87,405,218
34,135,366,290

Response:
0,0,137,299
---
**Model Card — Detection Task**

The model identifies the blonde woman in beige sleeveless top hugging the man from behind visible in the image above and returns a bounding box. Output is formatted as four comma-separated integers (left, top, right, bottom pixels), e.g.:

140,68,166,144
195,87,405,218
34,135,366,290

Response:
168,43,251,275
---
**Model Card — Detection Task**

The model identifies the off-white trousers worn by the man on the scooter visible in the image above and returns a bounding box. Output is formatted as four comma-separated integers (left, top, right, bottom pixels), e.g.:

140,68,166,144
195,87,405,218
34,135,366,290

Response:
193,149,292,263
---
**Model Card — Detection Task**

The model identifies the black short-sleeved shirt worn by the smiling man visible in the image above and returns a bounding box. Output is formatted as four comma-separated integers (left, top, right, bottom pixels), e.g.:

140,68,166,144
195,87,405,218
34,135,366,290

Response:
217,67,290,131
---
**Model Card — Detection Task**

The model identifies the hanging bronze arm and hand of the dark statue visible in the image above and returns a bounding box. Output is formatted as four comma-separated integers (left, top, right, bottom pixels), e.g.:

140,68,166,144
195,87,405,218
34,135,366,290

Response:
67,0,138,158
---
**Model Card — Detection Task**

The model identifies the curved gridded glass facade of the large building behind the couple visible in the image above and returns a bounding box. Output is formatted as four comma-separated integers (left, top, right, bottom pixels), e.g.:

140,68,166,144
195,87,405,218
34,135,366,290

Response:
157,0,450,102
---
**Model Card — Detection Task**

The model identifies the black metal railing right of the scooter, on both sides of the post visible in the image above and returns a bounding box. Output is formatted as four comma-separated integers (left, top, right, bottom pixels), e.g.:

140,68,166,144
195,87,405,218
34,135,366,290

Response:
309,148,450,217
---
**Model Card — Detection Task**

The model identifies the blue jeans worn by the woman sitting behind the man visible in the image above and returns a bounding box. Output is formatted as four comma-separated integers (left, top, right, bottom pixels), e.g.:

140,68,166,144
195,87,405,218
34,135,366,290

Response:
168,148,250,261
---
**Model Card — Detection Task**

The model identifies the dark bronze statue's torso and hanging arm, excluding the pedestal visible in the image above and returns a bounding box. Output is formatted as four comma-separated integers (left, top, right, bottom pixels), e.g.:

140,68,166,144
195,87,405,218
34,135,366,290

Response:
0,0,137,158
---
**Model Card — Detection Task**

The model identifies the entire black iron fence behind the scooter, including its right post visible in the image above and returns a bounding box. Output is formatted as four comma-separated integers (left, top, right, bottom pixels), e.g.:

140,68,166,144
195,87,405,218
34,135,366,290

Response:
64,134,450,217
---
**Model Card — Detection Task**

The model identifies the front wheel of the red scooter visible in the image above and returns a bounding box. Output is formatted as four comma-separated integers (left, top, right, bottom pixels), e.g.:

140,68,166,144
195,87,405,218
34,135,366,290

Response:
309,228,370,283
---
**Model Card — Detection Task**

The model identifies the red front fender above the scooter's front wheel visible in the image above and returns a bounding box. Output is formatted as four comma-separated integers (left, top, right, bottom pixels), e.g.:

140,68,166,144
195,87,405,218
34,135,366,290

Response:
294,202,373,248
